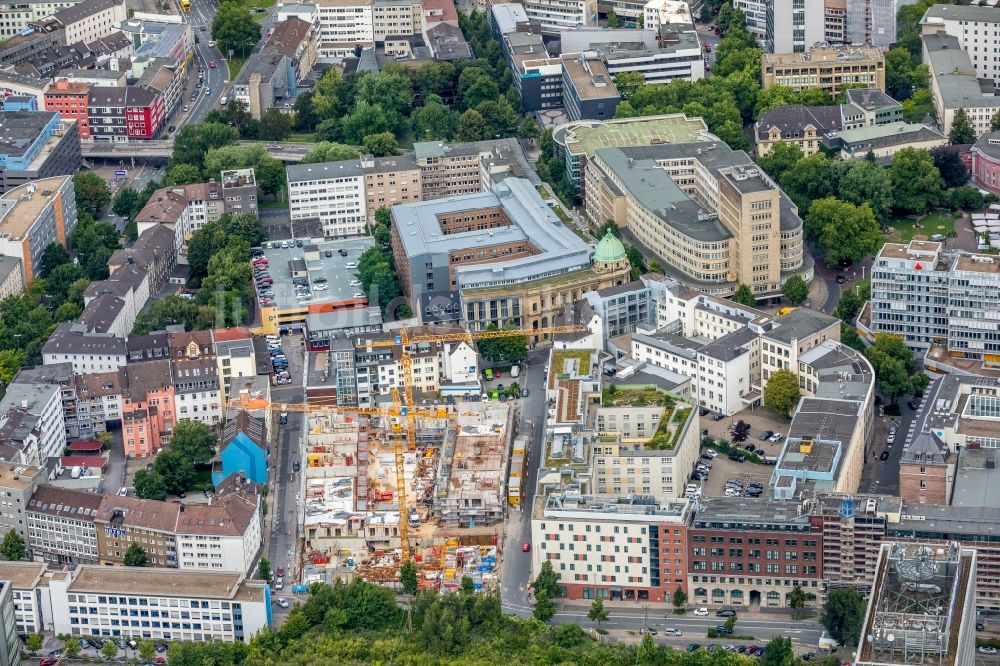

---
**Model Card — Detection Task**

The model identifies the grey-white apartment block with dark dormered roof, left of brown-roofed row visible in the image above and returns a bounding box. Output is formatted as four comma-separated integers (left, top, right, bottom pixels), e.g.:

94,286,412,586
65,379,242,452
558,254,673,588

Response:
26,486,103,566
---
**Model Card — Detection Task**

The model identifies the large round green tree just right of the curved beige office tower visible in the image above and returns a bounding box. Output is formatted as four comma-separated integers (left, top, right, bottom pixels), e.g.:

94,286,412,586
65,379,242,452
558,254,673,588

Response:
805,197,882,266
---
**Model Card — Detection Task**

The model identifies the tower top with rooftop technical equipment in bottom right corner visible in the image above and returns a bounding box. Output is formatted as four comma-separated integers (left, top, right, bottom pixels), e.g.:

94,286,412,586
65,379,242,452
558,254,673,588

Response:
854,542,976,666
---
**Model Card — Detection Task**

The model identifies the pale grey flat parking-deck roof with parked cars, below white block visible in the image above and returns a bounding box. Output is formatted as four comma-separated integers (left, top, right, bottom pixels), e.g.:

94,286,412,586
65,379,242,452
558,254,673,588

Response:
264,237,375,310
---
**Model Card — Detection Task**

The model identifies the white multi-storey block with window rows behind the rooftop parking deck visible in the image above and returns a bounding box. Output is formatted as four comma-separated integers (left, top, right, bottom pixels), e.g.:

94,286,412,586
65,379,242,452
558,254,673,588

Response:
287,162,368,238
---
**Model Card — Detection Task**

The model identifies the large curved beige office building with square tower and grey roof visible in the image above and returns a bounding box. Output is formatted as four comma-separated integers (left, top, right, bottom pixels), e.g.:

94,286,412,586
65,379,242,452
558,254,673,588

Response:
584,141,812,298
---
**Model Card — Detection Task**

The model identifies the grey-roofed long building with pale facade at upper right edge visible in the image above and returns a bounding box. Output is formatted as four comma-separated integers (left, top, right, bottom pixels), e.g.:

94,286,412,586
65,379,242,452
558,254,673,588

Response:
921,33,1000,137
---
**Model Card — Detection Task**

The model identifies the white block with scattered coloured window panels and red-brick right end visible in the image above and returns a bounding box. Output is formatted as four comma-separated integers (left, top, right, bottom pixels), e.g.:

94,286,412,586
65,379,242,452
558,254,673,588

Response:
531,494,691,602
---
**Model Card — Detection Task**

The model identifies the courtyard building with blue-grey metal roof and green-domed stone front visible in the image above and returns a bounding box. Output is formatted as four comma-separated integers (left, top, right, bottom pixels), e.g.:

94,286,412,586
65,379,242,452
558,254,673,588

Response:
392,178,628,330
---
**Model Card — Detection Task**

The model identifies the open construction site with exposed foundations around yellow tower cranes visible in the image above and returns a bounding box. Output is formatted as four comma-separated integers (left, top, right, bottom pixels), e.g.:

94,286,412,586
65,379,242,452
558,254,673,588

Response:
301,402,523,591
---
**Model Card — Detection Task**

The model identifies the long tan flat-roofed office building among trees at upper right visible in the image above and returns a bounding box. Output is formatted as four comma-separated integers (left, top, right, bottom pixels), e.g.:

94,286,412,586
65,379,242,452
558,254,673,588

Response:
761,44,885,97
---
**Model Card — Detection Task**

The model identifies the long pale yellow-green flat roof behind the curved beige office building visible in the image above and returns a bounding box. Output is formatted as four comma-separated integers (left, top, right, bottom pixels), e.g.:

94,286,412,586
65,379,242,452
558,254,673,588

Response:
553,113,718,156
